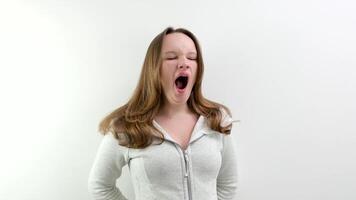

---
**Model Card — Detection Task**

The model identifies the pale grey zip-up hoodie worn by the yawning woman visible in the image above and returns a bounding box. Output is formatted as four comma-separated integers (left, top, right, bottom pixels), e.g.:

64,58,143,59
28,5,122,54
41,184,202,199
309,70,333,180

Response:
88,111,237,200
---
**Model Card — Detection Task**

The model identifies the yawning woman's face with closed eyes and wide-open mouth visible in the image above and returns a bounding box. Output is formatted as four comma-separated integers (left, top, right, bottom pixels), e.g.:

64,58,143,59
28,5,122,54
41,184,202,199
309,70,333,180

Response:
160,33,198,105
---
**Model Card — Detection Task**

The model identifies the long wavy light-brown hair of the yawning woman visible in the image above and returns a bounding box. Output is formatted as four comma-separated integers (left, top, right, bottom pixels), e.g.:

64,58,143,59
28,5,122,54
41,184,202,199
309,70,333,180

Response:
99,27,232,148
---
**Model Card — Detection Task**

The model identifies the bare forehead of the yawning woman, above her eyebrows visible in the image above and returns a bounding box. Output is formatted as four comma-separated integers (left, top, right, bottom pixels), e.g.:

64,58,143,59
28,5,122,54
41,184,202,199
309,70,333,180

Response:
162,33,196,53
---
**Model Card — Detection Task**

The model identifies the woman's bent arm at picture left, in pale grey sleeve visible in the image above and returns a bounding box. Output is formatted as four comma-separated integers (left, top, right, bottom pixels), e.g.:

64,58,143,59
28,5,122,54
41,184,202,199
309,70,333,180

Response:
88,133,128,200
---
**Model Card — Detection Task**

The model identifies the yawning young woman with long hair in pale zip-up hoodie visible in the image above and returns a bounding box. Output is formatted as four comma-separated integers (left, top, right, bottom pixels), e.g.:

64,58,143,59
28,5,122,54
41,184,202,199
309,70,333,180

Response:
88,27,237,200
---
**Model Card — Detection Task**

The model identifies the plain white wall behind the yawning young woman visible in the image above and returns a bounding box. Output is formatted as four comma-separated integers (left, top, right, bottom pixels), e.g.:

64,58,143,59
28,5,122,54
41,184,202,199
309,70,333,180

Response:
0,0,356,200
